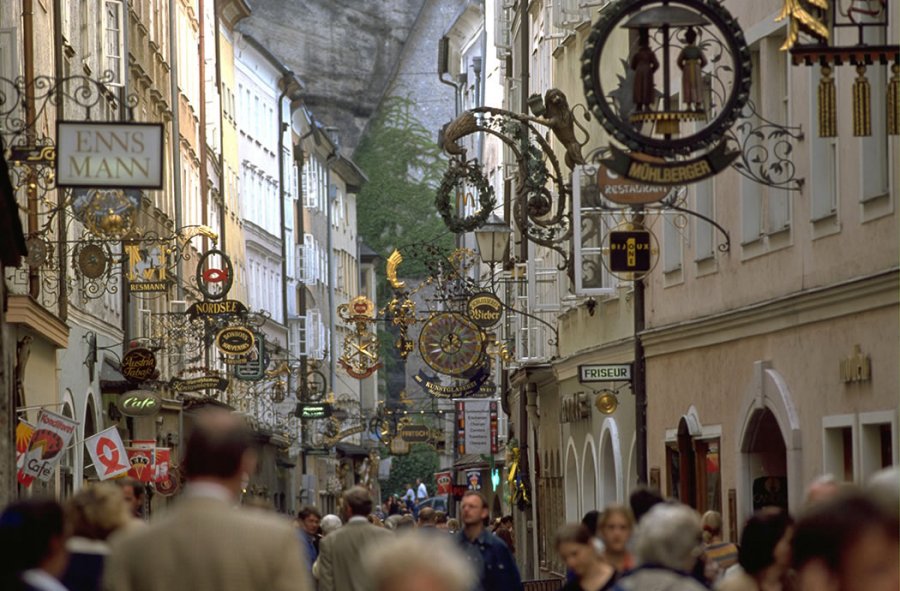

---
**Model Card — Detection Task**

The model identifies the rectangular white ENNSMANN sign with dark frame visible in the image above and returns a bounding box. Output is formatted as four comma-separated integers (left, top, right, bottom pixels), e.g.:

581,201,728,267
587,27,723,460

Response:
56,121,163,189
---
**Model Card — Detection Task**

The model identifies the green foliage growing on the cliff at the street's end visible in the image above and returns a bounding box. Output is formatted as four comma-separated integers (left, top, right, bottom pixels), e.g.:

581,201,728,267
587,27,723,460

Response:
353,96,454,294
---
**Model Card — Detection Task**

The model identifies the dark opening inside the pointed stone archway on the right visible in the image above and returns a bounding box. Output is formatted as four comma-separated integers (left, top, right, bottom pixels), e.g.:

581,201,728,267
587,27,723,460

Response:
741,408,789,511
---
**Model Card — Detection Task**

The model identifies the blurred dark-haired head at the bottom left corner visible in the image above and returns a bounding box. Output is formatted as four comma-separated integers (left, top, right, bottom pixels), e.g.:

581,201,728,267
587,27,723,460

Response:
0,499,65,589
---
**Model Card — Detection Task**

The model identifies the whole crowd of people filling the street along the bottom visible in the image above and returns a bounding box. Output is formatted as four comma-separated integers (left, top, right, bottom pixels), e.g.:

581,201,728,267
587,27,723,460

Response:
0,411,900,591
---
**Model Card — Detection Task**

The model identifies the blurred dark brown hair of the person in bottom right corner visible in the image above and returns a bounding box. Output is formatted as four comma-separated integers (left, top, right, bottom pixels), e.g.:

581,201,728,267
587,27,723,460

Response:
792,492,900,572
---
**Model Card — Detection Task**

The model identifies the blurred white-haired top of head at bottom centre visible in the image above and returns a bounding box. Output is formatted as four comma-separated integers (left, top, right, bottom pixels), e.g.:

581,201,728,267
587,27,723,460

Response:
365,532,477,591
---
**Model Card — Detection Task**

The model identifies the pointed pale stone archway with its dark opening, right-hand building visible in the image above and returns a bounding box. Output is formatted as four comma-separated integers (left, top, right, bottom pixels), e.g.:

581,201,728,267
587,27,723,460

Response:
737,361,803,523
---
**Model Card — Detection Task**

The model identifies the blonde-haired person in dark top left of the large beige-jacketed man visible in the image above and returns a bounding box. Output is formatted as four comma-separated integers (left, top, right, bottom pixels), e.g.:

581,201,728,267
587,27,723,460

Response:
61,482,131,591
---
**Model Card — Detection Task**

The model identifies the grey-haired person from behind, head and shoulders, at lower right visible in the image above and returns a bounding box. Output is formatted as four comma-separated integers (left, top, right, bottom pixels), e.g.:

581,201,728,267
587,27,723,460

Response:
613,503,705,591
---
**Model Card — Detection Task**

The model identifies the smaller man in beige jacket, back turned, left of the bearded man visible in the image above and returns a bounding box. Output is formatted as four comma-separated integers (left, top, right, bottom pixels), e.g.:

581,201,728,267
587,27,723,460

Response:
317,486,392,591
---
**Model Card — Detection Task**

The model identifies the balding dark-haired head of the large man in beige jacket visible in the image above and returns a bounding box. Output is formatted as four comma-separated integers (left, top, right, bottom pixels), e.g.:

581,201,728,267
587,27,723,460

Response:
182,409,253,479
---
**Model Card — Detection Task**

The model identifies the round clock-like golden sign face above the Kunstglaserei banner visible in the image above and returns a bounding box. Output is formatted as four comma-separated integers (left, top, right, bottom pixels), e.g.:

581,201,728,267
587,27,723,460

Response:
419,312,484,376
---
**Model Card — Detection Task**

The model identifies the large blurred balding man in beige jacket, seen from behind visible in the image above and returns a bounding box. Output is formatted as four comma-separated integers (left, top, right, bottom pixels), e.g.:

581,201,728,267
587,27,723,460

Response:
104,410,311,591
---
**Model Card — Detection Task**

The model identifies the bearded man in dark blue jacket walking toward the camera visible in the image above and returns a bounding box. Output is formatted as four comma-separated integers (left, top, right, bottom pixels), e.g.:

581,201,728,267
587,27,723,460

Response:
456,490,522,591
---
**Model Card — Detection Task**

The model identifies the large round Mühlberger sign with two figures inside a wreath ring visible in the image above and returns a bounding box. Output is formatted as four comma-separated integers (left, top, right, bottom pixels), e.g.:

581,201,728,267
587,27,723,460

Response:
581,0,752,186
